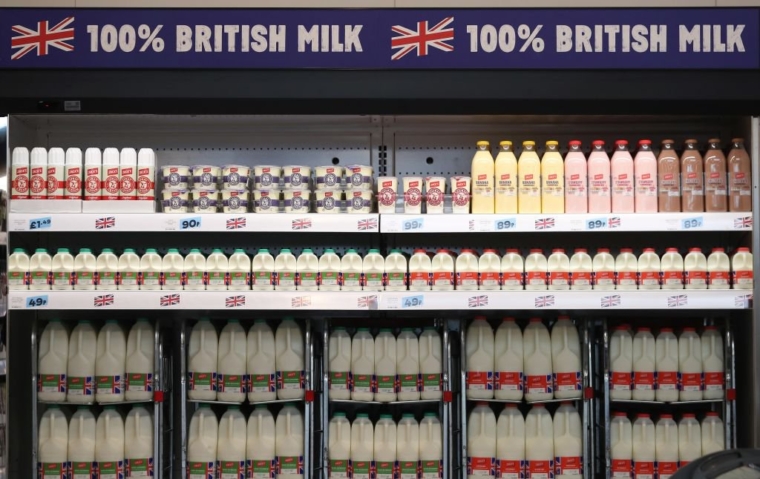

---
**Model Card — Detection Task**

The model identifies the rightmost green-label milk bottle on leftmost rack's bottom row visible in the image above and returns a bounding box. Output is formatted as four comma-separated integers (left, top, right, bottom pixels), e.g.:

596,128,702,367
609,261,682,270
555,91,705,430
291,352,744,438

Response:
124,406,154,479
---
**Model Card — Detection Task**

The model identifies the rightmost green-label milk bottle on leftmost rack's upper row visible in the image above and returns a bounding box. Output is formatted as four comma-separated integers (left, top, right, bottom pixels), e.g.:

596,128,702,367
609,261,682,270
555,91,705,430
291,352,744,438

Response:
124,319,155,401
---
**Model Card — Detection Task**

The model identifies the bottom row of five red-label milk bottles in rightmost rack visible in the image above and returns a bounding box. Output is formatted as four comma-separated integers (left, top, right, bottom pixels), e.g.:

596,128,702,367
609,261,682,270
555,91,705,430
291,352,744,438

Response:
610,412,725,478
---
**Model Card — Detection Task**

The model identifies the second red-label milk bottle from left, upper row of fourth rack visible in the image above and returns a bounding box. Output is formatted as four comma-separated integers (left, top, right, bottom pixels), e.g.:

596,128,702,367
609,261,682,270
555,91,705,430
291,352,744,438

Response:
493,318,523,404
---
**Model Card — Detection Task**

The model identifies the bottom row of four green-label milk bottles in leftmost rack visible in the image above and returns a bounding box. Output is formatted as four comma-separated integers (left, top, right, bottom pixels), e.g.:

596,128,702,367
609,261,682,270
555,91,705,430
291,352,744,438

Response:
37,406,153,479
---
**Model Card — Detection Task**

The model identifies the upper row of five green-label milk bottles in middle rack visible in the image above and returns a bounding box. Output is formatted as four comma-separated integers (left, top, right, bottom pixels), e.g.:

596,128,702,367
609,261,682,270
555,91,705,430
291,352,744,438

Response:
328,328,443,402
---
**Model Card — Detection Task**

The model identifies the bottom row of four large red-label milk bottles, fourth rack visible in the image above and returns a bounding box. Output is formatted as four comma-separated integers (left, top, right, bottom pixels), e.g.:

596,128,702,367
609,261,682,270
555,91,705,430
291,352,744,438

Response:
467,402,583,479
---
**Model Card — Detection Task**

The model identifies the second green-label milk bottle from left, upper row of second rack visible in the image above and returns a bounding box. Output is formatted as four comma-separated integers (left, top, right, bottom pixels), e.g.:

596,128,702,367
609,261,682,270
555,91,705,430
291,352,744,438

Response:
216,319,248,402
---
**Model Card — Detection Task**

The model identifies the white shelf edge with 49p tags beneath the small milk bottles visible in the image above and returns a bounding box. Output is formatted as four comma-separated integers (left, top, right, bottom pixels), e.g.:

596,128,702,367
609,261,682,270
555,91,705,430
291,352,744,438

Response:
9,290,752,314
